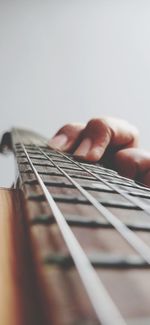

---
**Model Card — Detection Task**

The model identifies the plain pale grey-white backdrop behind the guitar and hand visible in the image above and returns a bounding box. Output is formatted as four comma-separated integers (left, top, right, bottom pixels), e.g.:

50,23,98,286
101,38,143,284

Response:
0,0,150,186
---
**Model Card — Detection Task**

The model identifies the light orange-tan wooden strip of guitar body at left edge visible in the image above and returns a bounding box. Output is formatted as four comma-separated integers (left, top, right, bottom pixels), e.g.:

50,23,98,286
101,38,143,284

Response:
0,189,21,325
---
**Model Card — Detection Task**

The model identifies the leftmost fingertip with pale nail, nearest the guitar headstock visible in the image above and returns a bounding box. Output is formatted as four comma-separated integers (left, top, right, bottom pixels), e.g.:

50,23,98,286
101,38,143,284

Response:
48,123,85,151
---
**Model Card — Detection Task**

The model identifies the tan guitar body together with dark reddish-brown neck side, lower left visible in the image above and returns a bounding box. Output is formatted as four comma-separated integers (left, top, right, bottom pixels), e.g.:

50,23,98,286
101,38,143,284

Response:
0,189,46,325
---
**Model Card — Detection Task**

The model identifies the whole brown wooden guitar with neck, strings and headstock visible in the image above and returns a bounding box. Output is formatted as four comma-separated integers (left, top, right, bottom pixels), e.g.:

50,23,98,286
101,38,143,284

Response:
0,129,150,325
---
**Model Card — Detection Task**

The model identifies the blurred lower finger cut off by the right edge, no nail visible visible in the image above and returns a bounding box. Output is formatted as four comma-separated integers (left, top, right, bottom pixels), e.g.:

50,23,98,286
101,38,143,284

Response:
113,148,150,187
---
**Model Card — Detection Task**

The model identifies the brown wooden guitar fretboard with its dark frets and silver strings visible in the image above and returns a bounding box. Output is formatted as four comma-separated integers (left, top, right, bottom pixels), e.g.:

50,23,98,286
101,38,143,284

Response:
3,129,150,325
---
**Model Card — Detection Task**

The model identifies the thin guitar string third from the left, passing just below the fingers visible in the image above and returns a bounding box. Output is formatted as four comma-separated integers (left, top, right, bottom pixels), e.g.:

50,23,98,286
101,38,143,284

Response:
57,151,150,215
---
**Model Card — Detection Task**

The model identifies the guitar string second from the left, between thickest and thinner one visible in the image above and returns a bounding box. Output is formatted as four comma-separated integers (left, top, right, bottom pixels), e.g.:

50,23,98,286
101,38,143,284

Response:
36,146,150,264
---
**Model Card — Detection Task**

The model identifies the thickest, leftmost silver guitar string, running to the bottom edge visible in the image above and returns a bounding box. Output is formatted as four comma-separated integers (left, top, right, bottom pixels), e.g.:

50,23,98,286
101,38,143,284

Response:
22,144,126,325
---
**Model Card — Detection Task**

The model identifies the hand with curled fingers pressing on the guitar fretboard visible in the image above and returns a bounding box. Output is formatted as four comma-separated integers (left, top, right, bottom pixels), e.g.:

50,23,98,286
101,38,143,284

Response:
49,117,150,187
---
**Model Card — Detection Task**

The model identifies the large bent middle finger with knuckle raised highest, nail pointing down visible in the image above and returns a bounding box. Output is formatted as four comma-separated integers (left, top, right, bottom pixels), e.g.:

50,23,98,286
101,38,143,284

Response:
74,118,138,161
